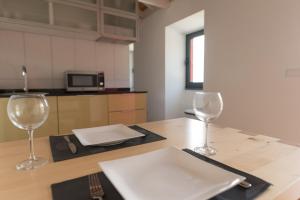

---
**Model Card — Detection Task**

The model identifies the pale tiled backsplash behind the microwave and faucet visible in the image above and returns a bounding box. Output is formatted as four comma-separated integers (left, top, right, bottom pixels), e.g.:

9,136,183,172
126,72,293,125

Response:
0,30,129,89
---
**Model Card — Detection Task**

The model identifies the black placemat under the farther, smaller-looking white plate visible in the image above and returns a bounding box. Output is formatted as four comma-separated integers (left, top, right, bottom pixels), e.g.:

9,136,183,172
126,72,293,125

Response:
49,125,166,162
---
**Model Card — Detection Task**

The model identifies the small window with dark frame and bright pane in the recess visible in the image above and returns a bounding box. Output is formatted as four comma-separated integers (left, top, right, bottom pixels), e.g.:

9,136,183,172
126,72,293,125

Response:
185,30,205,90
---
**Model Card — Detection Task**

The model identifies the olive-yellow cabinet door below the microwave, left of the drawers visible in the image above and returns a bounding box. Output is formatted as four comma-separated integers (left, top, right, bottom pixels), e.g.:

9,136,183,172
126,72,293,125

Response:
58,95,108,134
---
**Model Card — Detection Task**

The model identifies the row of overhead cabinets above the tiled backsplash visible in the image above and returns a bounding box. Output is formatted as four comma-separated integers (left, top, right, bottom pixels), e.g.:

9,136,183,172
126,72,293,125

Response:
0,0,138,42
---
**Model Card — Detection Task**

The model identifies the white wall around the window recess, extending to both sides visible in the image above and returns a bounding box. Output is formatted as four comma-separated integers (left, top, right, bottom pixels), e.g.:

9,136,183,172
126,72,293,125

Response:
135,0,300,143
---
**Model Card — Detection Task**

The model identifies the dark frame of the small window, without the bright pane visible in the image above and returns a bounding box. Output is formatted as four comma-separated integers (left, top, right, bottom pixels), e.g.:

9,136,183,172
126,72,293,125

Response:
185,29,204,90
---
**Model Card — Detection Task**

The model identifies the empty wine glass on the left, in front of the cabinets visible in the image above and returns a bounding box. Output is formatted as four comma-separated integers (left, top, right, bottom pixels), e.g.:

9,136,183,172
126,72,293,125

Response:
7,93,49,170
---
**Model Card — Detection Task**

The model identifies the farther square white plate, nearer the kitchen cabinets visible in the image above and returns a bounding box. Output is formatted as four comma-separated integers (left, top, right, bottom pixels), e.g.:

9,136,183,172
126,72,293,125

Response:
73,124,145,146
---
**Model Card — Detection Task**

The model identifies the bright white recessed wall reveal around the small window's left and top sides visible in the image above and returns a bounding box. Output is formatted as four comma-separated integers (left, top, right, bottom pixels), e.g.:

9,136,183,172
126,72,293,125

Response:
165,10,204,119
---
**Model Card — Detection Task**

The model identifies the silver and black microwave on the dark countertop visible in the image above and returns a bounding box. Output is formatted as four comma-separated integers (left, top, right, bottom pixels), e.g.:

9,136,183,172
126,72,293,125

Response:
65,71,104,92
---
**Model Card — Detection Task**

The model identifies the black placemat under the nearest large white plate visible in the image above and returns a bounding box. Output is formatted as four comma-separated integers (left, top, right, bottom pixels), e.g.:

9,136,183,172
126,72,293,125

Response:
51,149,271,200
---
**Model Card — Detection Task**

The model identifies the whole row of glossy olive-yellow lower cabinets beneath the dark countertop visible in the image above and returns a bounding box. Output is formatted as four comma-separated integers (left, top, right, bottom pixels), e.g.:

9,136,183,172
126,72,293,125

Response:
0,94,147,142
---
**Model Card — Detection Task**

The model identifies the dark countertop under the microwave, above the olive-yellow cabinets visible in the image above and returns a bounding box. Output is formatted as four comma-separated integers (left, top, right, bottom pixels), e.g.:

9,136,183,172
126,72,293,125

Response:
0,88,147,98
